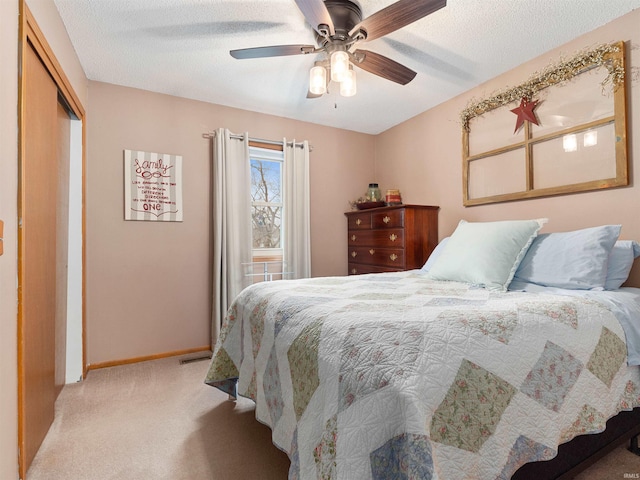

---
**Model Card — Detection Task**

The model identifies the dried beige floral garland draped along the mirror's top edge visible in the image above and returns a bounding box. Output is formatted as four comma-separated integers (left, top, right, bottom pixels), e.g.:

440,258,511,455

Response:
460,44,624,132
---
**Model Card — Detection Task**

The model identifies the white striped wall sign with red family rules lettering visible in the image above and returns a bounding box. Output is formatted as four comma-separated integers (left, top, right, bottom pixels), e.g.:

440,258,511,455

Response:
124,150,182,222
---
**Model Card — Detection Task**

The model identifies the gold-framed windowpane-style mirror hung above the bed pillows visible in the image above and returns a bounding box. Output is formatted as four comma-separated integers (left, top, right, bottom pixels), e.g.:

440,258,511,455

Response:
461,41,629,206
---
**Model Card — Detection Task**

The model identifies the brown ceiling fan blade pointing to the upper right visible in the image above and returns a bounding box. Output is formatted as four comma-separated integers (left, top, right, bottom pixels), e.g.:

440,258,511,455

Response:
349,0,447,40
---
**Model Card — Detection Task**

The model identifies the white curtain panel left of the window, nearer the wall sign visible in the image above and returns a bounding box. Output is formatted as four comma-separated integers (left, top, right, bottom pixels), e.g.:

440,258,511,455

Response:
211,128,251,345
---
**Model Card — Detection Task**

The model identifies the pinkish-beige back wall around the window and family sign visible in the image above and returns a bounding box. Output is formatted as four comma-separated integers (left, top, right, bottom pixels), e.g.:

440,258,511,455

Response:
86,82,374,364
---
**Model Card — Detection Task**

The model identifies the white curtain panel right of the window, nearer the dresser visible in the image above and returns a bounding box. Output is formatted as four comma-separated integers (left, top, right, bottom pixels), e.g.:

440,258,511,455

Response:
283,138,311,278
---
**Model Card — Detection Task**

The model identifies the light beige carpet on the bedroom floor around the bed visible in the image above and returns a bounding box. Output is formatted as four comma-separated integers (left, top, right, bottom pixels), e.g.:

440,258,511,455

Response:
27,357,640,480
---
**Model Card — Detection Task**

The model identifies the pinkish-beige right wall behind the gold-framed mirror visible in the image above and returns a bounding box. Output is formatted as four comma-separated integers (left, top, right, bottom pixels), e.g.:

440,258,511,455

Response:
375,10,640,284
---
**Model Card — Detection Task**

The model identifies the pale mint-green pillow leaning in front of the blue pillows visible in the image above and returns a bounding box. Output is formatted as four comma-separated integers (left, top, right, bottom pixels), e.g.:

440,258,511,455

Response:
427,218,547,291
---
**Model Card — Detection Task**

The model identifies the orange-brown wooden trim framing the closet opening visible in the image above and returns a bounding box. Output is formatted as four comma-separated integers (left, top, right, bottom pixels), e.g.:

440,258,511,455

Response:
17,0,87,479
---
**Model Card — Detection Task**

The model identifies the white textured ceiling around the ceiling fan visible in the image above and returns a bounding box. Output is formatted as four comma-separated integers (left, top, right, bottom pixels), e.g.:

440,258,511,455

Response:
54,0,640,134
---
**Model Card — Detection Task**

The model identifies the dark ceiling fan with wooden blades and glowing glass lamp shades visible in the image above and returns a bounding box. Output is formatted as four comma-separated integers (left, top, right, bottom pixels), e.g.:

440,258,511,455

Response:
229,0,447,98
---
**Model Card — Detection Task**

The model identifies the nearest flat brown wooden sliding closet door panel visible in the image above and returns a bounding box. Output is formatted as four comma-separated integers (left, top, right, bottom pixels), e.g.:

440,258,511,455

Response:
18,45,58,472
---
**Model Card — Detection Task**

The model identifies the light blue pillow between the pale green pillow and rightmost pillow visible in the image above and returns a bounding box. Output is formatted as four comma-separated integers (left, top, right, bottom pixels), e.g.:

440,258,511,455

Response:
513,225,622,290
